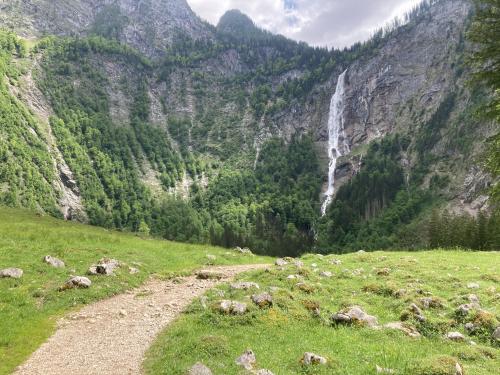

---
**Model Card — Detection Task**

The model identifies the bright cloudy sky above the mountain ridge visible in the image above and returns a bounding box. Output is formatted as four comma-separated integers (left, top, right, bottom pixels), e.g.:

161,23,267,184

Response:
187,0,421,48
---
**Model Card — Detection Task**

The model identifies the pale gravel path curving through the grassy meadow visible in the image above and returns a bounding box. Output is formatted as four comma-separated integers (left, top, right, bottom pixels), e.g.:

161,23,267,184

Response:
15,265,266,375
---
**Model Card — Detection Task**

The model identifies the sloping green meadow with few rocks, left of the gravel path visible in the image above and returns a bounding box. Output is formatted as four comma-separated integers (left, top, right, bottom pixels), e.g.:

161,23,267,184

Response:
0,208,269,374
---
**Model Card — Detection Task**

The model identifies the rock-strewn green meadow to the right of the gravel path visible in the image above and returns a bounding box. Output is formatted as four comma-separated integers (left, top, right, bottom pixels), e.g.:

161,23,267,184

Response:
145,251,500,375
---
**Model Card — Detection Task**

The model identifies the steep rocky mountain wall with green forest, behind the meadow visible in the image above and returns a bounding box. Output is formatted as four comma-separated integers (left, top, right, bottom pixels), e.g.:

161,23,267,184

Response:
0,0,498,253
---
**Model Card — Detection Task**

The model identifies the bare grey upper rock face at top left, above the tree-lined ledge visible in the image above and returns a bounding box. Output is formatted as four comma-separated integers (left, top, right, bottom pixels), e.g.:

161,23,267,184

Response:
0,0,213,56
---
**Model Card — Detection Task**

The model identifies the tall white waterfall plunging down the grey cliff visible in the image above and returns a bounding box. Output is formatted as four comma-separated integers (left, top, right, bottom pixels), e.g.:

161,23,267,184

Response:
321,70,349,216
